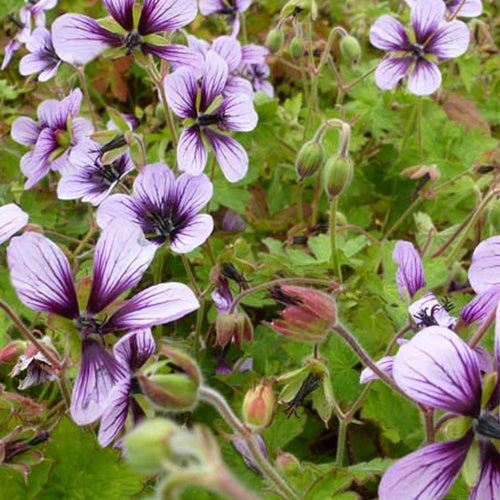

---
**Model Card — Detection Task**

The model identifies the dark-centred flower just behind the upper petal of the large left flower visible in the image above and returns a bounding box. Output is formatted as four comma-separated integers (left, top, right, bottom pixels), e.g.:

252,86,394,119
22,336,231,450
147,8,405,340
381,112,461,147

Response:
97,163,214,253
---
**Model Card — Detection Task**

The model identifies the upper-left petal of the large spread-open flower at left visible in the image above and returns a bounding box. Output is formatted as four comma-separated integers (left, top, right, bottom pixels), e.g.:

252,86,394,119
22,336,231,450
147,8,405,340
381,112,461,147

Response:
7,233,78,319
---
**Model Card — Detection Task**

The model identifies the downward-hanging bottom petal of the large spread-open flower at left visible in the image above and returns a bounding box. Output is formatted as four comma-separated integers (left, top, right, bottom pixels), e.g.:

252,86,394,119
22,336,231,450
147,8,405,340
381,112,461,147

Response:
70,338,128,425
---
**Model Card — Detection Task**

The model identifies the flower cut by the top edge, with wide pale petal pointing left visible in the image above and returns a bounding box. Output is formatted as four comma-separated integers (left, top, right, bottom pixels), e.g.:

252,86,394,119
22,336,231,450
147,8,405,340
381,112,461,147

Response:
52,0,201,68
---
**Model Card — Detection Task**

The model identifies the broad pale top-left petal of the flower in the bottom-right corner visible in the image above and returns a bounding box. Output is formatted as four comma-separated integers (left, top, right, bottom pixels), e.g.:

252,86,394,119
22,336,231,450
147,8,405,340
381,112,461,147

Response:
393,326,482,417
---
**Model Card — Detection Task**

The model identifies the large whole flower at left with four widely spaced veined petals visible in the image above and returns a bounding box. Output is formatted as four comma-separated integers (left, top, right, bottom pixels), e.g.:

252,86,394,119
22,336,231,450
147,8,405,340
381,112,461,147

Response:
7,225,198,425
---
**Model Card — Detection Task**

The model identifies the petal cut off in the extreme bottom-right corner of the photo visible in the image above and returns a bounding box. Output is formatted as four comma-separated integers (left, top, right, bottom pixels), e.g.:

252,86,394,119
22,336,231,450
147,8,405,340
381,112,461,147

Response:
469,441,500,500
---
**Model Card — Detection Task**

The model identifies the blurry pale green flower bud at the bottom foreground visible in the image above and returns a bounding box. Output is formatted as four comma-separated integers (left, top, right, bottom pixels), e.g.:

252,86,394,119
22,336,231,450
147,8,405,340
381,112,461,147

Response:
123,418,179,474
